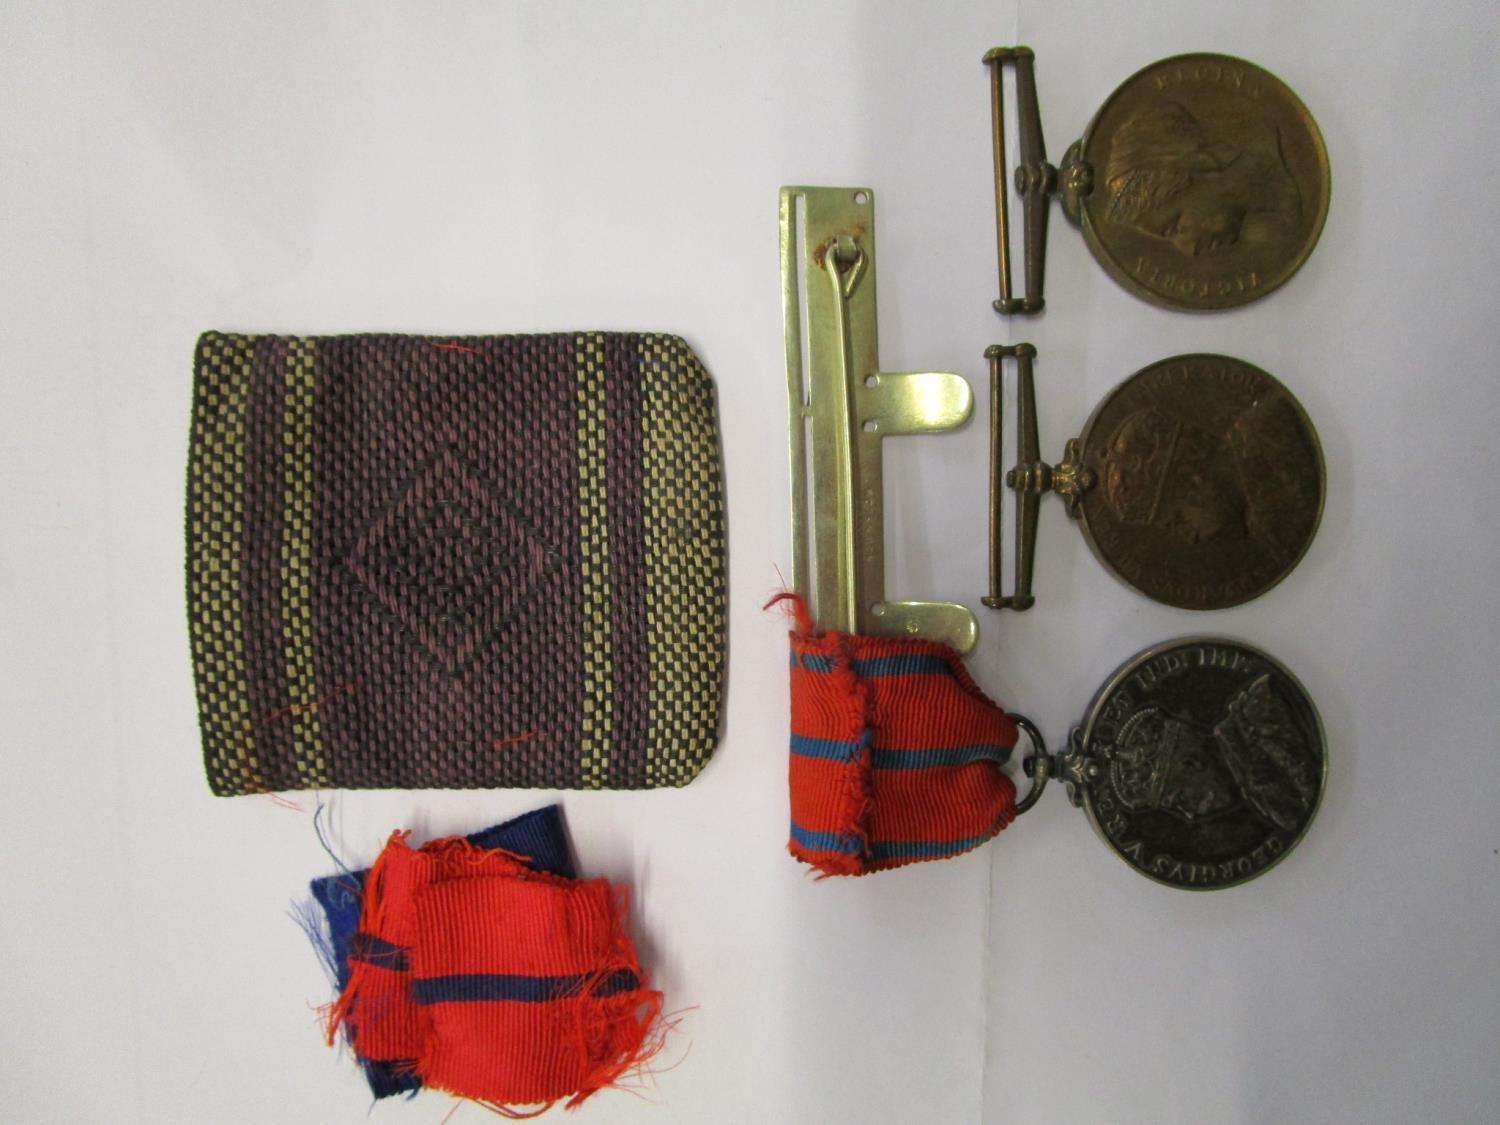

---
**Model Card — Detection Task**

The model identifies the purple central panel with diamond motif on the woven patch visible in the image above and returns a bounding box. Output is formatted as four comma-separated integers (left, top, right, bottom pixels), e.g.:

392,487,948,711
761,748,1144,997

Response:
314,338,579,788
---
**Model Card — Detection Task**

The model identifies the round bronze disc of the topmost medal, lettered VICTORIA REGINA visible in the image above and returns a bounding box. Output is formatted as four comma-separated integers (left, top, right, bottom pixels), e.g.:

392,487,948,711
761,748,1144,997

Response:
1064,54,1329,309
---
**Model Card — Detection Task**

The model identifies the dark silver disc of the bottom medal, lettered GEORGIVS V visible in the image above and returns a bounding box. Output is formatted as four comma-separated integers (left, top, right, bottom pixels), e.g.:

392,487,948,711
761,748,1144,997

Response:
1056,638,1328,890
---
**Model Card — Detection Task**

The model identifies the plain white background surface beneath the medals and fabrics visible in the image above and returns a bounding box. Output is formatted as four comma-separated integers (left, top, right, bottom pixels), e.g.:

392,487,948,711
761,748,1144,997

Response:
0,0,1500,1125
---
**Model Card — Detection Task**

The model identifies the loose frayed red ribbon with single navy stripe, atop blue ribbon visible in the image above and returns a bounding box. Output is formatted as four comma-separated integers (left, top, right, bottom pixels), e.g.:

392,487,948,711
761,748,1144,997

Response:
327,833,662,1112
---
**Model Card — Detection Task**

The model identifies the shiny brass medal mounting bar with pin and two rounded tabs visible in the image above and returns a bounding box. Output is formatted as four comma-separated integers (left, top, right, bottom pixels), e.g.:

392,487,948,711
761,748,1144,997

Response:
780,188,978,653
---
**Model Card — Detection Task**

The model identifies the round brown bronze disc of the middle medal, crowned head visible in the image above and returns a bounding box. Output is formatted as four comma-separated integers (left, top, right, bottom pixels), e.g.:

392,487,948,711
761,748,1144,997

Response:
1077,356,1323,609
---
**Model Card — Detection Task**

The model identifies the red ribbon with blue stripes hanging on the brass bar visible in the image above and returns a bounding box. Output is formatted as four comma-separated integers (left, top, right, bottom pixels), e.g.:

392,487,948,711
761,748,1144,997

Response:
788,609,1016,875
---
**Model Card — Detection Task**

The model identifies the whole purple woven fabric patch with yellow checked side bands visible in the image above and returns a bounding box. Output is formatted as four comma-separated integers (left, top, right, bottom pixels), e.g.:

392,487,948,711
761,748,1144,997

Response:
188,333,726,795
